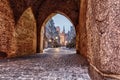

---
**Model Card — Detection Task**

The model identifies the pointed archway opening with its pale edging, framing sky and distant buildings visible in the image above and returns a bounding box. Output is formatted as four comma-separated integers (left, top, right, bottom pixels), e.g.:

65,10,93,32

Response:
40,12,76,53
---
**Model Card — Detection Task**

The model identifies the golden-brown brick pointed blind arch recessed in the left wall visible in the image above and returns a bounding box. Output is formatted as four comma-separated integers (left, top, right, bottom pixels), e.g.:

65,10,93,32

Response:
15,8,36,56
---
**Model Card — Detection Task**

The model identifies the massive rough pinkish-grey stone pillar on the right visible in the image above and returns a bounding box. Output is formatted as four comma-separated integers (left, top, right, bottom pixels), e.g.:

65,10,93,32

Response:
86,0,120,80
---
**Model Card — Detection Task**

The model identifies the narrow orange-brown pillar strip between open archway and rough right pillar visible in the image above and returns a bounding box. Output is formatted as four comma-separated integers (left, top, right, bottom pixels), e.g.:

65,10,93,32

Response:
78,0,87,57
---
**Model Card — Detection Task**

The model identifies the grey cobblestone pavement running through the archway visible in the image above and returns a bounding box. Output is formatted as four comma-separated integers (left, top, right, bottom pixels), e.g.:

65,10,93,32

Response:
0,48,90,80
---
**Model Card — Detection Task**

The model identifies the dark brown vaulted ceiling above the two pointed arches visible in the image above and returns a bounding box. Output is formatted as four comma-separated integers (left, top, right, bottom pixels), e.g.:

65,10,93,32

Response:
9,0,80,24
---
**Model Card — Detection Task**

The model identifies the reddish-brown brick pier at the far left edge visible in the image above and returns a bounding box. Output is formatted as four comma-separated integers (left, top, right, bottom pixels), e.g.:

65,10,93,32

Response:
0,0,15,57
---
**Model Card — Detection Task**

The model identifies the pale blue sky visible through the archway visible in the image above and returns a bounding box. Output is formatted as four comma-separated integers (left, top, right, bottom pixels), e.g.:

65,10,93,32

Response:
52,14,73,33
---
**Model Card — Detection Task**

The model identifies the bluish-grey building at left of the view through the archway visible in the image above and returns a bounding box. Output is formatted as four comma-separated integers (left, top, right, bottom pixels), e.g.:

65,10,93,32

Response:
44,19,60,48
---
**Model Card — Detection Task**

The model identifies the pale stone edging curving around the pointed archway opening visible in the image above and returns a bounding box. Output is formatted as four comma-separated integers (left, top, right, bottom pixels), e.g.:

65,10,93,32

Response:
40,11,76,52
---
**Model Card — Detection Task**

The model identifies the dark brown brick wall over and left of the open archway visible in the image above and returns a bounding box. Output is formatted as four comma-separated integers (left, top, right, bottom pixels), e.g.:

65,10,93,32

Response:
37,0,79,51
